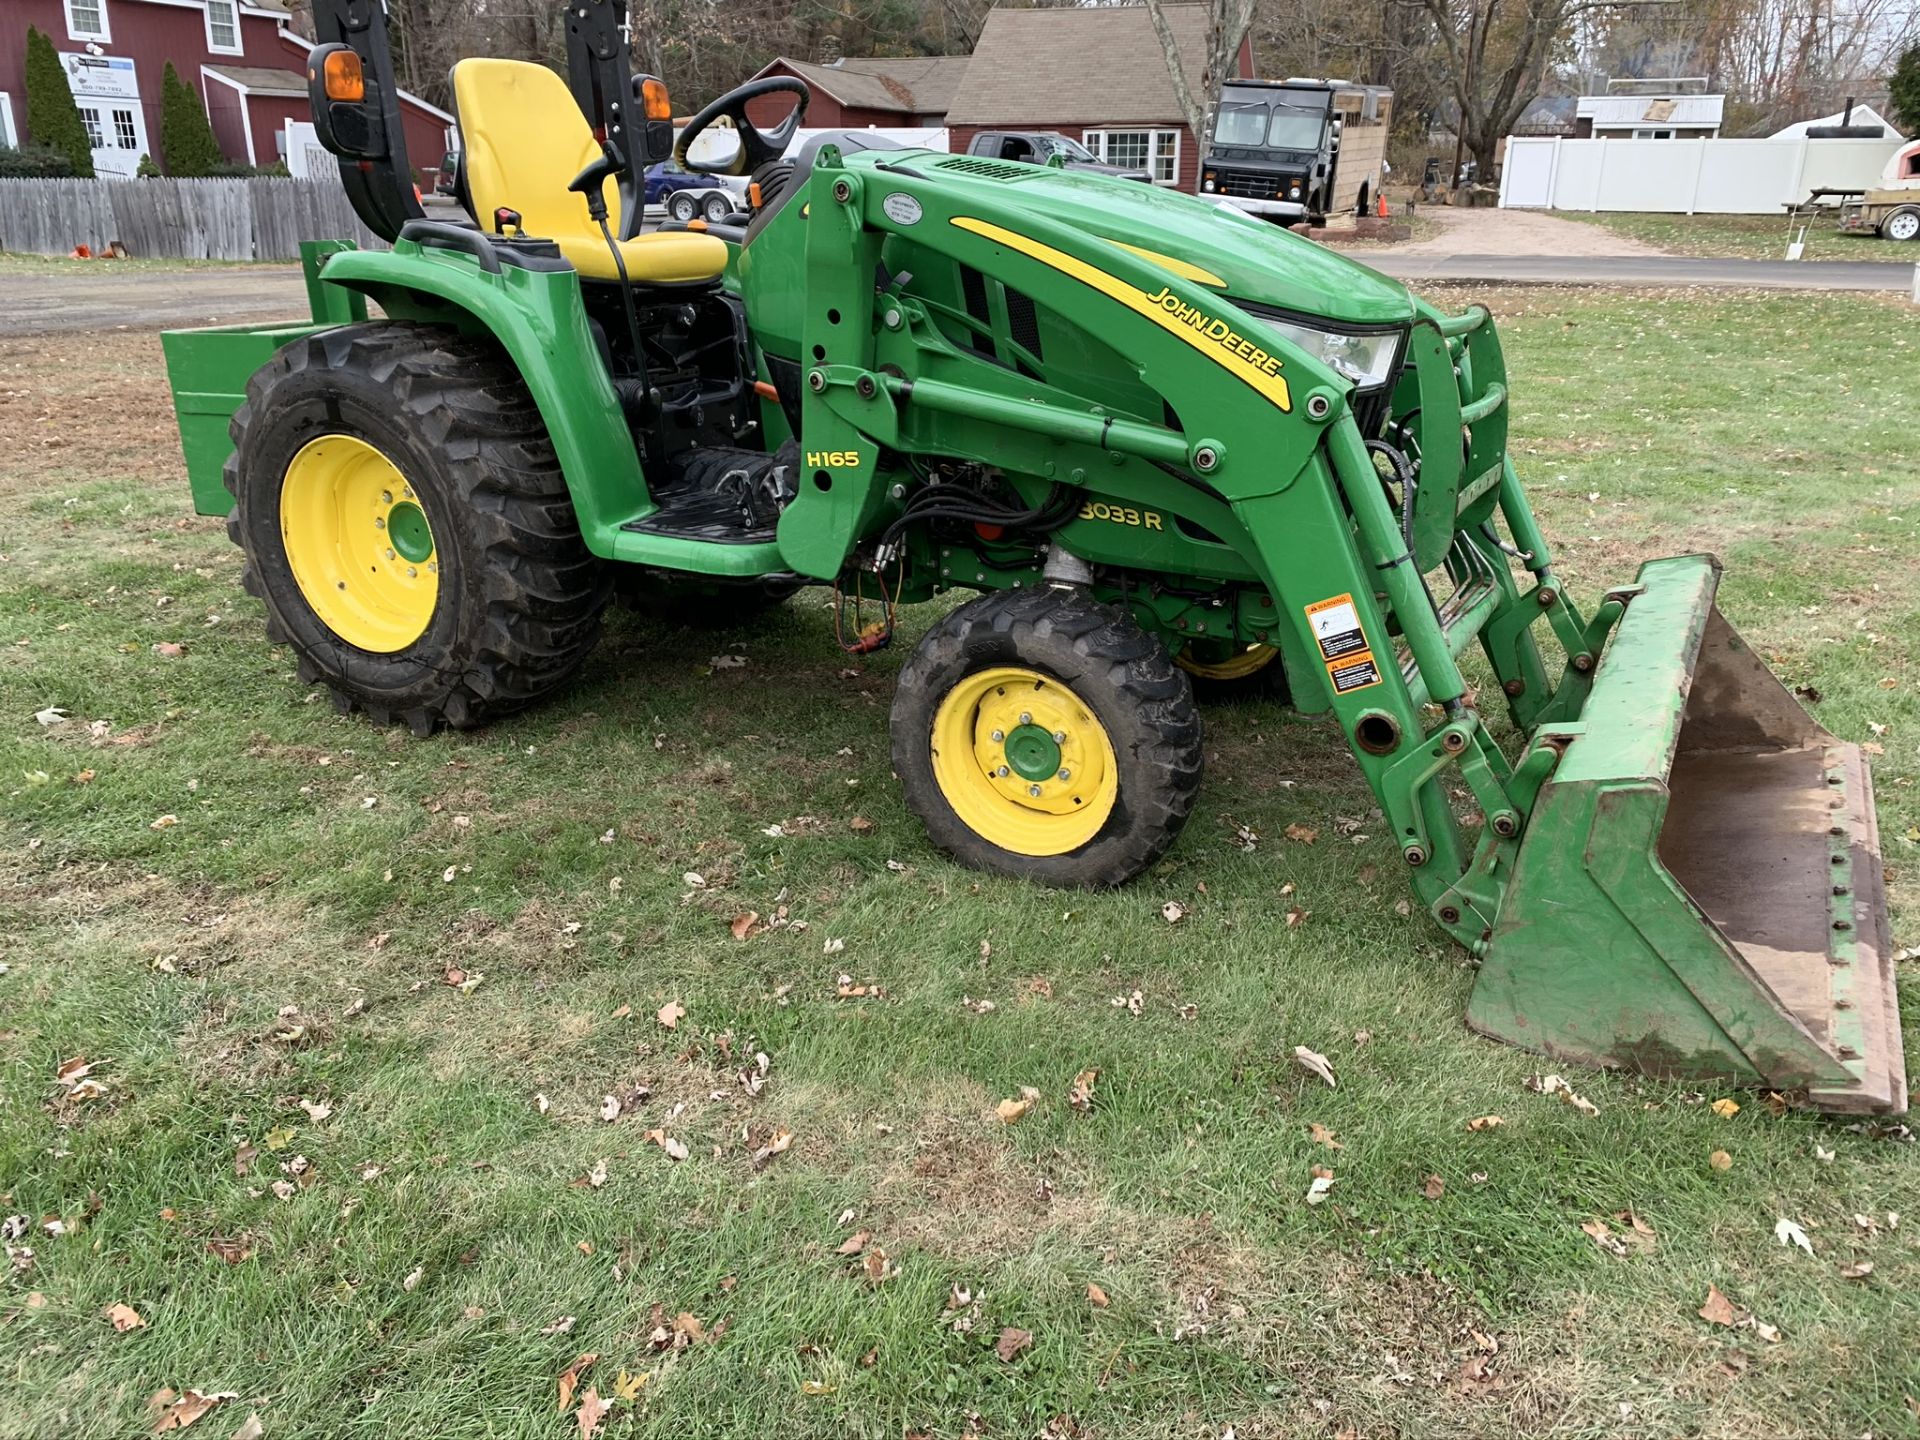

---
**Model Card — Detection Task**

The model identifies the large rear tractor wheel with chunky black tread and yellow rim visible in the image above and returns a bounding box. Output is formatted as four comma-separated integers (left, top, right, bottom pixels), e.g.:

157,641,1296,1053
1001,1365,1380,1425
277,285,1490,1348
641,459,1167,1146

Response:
225,323,611,735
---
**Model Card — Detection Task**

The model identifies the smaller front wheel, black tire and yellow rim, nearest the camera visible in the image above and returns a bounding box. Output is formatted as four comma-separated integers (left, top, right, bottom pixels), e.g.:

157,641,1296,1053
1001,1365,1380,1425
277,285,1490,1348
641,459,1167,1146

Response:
893,588,1202,887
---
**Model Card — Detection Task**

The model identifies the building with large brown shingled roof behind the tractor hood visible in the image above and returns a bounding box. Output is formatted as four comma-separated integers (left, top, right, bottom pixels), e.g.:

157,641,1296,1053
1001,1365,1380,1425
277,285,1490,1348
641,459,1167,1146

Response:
947,6,1254,194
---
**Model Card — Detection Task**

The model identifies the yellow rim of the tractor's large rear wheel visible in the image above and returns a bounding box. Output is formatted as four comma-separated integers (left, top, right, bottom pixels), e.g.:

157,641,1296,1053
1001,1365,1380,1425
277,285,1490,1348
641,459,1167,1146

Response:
280,436,440,655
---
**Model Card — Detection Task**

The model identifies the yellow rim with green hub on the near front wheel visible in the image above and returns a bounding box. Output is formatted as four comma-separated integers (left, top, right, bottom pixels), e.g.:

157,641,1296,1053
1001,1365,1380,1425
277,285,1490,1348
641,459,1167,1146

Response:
931,666,1119,854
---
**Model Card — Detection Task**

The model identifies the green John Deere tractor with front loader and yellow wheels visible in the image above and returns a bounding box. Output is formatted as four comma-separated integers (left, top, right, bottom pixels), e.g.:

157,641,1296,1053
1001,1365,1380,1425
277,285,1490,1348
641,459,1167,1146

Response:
165,0,1907,1112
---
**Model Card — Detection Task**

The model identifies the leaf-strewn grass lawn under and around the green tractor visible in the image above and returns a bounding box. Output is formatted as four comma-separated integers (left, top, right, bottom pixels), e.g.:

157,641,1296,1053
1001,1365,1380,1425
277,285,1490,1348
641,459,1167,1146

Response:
0,290,1920,1440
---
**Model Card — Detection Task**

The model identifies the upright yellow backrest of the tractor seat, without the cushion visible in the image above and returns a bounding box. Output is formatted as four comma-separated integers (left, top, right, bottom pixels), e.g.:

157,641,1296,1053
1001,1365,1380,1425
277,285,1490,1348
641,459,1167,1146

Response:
453,60,620,238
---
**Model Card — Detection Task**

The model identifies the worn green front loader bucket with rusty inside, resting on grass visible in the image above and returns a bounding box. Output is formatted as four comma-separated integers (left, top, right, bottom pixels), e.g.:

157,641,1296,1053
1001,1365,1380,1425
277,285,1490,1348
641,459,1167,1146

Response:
1467,555,1907,1112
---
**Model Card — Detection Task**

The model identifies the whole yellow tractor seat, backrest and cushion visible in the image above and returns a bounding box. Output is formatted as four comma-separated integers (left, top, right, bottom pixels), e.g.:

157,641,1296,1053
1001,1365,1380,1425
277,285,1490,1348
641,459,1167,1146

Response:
453,60,726,284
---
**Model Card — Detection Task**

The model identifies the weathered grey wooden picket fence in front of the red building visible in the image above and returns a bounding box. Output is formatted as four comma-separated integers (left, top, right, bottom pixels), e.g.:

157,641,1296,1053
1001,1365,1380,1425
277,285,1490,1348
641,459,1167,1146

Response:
0,177,380,259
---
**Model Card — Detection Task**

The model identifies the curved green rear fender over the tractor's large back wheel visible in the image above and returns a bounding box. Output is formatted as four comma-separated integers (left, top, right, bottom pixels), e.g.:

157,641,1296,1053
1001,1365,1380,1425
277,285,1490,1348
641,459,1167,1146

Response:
321,240,655,559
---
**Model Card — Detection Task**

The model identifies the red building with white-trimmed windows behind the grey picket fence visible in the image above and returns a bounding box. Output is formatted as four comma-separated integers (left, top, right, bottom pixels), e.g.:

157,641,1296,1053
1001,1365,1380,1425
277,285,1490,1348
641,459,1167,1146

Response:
0,0,453,179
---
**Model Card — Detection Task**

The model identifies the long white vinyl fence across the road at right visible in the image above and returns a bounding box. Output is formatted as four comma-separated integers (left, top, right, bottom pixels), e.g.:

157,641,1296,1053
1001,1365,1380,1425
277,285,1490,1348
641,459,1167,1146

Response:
1500,136,1903,215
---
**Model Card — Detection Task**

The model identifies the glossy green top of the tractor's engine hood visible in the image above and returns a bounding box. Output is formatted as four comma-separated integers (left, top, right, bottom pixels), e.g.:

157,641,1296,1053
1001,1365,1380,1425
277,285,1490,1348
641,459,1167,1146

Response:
879,152,1415,326
